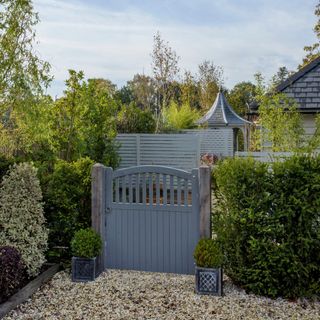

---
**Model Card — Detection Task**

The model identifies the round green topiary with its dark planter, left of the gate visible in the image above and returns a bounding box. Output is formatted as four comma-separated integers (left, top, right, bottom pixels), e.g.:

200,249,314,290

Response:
71,228,102,282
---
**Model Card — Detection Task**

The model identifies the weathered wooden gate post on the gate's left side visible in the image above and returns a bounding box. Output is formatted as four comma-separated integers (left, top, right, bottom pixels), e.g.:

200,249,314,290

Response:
91,163,106,272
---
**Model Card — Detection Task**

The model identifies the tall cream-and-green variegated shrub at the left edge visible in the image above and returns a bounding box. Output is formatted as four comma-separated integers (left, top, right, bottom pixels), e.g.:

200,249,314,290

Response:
0,163,48,276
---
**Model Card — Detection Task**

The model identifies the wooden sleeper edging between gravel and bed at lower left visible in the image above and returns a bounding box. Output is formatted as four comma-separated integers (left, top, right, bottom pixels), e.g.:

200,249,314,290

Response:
0,264,59,319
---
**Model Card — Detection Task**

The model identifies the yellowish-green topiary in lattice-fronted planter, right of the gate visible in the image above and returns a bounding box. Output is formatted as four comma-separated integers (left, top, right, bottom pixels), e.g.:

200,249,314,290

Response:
193,239,223,296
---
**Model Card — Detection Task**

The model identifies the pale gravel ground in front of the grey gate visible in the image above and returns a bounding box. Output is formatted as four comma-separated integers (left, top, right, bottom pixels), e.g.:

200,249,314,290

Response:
4,270,320,320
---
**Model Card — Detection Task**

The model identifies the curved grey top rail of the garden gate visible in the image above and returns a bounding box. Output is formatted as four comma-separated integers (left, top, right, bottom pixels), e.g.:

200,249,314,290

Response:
113,165,198,179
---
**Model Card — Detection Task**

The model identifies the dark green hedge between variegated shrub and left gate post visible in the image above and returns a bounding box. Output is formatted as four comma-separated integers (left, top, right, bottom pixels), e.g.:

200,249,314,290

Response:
43,158,94,255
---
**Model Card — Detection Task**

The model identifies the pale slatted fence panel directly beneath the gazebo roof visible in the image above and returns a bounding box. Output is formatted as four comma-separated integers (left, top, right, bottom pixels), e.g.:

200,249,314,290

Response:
183,128,234,157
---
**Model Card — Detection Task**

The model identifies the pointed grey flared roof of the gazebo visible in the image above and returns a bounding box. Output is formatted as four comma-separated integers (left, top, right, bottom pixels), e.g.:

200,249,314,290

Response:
197,91,251,128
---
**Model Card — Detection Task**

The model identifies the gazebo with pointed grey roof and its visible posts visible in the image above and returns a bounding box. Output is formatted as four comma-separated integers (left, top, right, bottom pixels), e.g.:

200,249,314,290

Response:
197,91,251,151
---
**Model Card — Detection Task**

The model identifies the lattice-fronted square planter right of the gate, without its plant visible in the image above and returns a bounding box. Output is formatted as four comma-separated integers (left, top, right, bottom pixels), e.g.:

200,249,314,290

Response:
196,266,223,296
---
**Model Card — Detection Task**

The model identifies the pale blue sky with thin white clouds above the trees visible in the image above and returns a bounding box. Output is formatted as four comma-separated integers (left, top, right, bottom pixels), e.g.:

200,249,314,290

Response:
34,0,317,97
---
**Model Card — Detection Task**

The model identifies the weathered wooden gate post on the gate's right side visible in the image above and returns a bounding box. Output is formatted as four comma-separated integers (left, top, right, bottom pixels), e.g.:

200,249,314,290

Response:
199,166,211,238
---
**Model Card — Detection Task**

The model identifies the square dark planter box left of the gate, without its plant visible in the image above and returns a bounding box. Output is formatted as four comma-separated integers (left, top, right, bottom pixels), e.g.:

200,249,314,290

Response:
72,257,99,282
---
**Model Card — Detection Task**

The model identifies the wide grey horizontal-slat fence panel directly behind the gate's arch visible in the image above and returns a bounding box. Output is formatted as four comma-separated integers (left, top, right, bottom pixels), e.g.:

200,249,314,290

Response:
116,133,200,172
